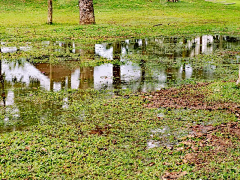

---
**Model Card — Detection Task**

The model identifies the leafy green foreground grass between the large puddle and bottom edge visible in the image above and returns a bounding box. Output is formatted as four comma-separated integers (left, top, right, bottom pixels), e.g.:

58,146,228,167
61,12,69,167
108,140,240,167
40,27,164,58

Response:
0,90,239,179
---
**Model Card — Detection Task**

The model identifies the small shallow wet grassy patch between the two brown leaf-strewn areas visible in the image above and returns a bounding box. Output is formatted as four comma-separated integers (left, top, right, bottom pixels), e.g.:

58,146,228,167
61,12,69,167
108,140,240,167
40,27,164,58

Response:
146,108,237,149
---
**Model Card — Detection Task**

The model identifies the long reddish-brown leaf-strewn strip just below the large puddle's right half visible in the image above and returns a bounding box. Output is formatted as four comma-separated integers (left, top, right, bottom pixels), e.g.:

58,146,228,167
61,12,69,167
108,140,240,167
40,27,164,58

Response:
143,83,240,117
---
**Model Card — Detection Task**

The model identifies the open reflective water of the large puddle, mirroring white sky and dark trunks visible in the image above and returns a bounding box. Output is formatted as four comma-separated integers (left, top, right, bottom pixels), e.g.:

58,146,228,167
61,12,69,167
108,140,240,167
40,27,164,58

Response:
0,35,240,133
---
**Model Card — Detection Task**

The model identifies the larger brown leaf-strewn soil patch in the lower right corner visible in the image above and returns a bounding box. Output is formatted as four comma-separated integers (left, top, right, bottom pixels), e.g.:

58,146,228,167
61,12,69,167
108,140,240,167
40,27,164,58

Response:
181,122,240,168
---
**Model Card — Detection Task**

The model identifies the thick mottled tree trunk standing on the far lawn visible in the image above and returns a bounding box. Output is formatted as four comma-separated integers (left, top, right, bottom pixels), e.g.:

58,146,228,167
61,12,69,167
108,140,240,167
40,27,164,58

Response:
79,0,95,24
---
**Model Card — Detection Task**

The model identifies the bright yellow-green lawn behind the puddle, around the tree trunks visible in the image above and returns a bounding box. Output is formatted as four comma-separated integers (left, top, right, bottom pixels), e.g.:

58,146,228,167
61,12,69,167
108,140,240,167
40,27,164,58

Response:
0,0,240,40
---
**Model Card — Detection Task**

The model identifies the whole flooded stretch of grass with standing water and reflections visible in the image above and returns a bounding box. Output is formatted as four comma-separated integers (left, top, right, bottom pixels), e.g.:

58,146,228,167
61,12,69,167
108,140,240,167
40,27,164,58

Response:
0,35,240,132
